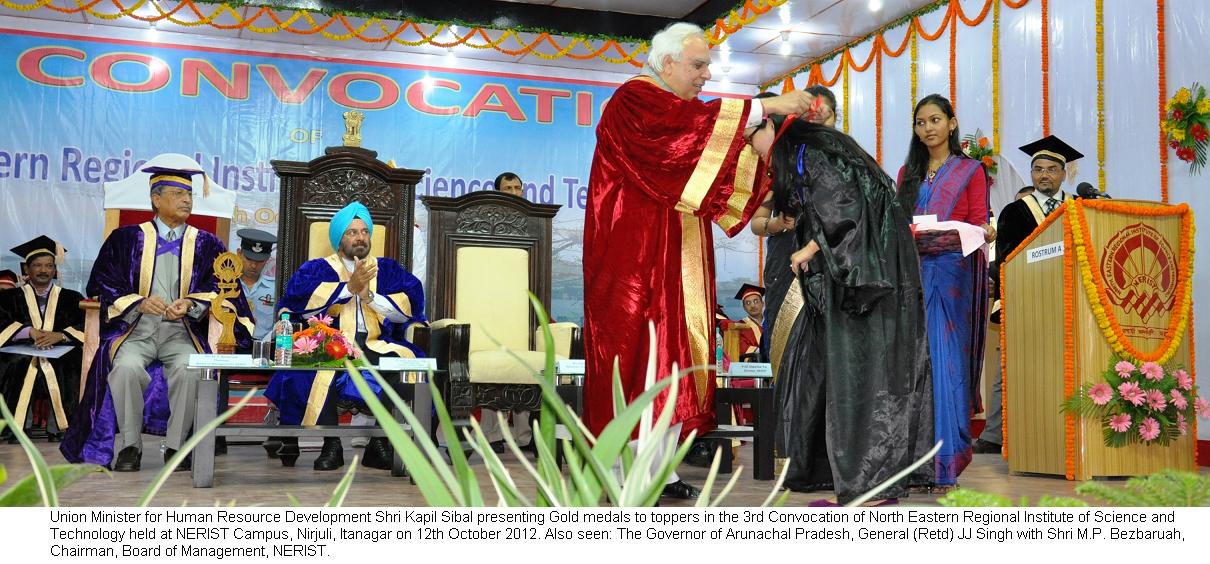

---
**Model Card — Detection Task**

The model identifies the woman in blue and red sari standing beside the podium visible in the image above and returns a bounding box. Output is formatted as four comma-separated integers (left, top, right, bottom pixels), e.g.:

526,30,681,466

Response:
898,94,995,493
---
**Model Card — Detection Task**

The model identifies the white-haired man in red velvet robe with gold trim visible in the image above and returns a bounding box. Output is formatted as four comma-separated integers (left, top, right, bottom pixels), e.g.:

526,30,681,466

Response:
583,23,812,499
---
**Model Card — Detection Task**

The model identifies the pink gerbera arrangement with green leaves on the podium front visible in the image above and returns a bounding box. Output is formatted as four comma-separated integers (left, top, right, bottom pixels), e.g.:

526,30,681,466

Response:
1062,361,1210,448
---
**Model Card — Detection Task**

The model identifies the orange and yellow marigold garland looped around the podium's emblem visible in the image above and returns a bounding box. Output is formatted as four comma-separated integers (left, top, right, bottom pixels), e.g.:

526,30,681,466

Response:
1066,200,1194,364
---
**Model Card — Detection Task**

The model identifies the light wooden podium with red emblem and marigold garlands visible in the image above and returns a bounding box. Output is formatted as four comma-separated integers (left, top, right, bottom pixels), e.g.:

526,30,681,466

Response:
1001,200,1195,479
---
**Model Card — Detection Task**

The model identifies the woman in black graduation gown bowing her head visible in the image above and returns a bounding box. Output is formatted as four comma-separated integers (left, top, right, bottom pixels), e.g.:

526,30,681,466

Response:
772,120,933,503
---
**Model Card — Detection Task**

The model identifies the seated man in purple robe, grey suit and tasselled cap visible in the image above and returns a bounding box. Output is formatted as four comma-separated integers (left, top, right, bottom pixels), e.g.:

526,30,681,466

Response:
59,163,253,472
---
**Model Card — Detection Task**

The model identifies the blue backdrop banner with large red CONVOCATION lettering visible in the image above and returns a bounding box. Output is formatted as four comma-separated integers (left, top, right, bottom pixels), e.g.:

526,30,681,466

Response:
0,23,757,322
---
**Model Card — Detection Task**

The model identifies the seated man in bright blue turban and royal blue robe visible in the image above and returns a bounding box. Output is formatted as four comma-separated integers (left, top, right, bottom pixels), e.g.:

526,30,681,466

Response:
265,202,425,470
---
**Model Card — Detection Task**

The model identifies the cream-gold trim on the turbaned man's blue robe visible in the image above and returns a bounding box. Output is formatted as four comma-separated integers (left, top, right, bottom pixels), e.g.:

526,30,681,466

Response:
303,254,416,425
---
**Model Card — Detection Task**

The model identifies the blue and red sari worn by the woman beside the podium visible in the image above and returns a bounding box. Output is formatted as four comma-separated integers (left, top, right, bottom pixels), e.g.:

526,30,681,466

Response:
900,157,987,487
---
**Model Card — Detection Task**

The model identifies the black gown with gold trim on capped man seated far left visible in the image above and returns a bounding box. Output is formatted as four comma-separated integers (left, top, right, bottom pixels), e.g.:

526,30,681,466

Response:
0,286,83,431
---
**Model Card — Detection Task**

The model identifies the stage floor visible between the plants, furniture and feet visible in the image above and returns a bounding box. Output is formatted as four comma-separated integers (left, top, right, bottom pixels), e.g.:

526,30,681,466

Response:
0,436,1210,507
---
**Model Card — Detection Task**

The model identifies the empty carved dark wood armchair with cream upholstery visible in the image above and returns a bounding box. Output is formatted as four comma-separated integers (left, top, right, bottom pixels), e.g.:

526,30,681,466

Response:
421,191,583,424
